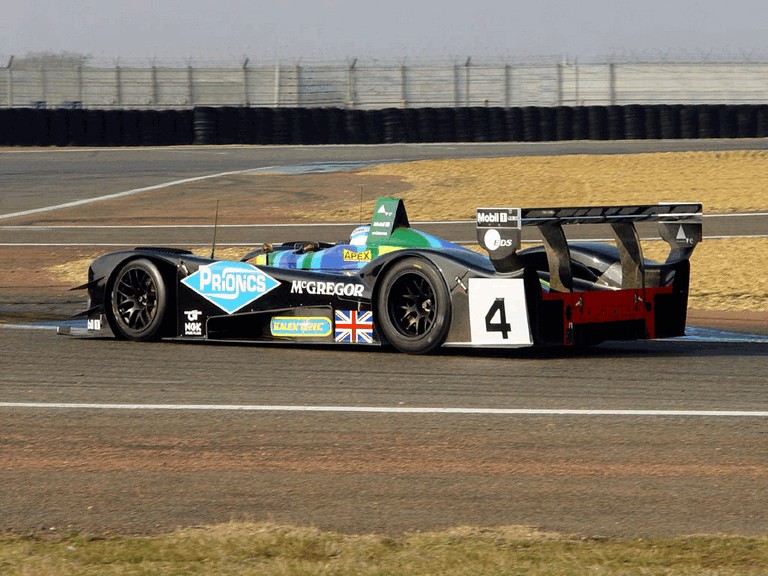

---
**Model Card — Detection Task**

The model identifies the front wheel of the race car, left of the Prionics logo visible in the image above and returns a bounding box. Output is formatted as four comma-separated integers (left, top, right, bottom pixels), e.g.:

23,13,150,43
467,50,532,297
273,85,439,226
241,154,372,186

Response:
110,258,168,342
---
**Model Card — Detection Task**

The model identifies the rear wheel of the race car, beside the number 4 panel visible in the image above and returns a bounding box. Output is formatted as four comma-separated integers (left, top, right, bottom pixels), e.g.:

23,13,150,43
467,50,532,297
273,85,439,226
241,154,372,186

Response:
376,258,451,354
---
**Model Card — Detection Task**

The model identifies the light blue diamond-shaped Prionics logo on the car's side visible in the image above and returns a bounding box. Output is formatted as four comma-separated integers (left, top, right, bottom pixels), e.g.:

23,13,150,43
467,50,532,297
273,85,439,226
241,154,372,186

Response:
181,262,280,314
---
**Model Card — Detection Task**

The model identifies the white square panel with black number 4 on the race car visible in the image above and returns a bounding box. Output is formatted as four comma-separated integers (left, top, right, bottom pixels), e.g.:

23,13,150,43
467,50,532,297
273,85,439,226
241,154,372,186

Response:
469,278,533,346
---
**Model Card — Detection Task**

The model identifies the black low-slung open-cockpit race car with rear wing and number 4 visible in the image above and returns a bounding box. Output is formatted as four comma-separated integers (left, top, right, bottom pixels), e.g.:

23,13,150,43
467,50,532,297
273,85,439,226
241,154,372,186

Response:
66,198,702,354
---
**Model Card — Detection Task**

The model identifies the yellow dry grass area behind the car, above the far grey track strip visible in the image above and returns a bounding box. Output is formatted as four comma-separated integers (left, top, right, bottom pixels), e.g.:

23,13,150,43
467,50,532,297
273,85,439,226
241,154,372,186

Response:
308,151,768,221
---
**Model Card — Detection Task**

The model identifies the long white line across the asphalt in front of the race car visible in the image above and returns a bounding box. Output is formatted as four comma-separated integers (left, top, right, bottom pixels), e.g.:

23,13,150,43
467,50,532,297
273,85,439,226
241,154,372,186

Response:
0,402,768,418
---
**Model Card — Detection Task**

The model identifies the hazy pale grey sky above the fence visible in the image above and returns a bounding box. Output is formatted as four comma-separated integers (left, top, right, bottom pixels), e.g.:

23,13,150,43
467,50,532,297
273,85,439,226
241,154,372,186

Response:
0,0,768,66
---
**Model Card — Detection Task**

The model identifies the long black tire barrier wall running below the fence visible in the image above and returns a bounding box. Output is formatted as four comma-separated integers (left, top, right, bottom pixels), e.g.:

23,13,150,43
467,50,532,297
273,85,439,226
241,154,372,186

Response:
0,104,768,146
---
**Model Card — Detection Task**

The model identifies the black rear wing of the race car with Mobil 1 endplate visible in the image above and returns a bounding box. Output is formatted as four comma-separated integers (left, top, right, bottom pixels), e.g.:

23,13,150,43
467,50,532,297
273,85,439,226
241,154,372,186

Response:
477,203,702,292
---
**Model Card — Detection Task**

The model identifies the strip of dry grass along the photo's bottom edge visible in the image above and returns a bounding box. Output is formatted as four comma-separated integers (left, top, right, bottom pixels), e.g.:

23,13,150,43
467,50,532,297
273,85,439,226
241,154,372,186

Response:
0,523,768,576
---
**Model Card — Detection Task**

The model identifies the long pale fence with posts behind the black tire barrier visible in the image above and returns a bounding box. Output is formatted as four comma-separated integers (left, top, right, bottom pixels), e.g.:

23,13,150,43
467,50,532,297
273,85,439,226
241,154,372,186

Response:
0,57,768,110
